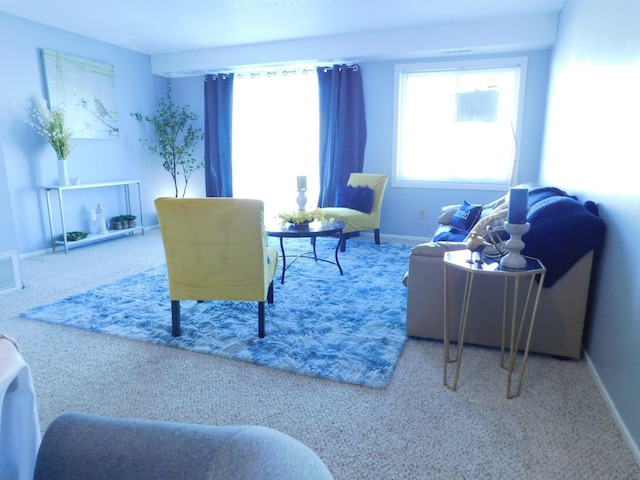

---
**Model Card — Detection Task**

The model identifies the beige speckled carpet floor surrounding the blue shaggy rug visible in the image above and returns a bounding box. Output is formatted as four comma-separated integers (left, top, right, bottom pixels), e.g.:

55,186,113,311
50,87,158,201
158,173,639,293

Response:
0,230,640,480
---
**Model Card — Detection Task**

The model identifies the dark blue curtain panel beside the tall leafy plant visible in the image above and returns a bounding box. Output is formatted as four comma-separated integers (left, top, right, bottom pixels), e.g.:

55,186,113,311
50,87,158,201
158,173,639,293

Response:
204,74,233,197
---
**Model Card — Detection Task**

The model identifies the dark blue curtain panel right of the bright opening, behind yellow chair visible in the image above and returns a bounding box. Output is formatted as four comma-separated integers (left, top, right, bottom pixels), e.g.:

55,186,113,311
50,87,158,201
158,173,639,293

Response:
318,65,367,207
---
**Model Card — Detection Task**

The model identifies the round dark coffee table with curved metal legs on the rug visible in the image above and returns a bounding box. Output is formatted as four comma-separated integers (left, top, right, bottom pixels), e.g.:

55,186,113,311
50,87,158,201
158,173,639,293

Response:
266,220,344,283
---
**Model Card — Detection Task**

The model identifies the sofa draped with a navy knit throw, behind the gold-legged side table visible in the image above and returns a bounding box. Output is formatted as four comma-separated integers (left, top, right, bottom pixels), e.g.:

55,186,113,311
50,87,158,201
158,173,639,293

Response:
404,185,605,358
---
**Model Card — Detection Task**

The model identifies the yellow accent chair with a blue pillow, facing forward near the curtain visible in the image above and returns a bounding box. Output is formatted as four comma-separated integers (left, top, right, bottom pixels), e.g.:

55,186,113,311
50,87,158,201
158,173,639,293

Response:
321,173,389,252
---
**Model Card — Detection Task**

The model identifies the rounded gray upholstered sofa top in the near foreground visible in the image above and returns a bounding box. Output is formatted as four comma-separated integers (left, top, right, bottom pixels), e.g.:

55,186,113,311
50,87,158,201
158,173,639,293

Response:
33,413,333,480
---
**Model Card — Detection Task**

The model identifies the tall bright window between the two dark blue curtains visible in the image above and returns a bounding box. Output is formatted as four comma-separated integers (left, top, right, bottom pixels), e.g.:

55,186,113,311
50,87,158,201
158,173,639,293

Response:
232,70,320,220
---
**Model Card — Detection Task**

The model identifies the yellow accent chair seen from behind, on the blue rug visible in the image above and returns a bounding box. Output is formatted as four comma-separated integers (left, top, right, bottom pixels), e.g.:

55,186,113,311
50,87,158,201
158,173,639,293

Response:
155,198,278,338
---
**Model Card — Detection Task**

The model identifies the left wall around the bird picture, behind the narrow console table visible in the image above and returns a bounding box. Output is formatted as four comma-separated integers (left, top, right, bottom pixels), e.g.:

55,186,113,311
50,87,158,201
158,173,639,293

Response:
0,13,171,253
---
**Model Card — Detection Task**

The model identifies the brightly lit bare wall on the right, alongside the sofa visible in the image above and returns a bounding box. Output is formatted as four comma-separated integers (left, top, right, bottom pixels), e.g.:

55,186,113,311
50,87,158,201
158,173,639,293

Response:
541,0,640,461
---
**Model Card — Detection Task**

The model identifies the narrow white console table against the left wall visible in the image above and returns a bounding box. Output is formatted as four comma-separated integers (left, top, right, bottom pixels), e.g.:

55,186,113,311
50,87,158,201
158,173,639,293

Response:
44,180,144,253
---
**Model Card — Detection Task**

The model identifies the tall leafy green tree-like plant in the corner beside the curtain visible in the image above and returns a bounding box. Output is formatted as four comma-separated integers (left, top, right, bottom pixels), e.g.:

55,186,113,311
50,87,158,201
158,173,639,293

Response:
131,84,204,198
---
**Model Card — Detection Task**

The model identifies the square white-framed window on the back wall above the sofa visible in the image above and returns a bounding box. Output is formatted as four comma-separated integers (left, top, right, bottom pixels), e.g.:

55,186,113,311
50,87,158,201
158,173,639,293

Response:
394,58,526,188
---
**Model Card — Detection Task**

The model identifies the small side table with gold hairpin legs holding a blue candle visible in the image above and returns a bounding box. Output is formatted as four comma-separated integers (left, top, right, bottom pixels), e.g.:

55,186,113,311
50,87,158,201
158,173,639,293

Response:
444,250,547,399
